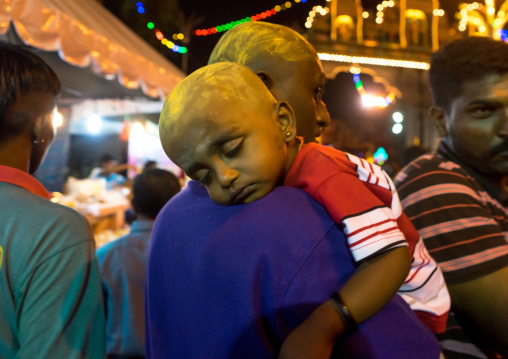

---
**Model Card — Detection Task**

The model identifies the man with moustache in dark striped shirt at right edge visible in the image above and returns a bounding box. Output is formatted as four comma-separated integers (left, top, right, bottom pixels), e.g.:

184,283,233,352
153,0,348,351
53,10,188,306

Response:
395,37,508,358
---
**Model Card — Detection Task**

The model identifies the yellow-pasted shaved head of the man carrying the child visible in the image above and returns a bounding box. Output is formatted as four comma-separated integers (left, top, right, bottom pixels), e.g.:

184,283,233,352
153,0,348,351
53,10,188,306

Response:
208,22,330,142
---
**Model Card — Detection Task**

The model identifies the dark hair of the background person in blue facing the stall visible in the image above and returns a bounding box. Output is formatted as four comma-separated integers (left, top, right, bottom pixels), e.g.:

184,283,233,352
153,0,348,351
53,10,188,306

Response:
131,168,180,219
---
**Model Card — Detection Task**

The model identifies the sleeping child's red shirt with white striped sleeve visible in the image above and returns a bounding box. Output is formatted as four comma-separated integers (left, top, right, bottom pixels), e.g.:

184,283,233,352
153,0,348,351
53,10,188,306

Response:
284,143,450,332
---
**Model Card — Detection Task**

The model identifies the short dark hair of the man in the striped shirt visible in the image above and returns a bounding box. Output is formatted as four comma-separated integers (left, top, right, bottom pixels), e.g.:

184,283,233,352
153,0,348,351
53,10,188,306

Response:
429,36,508,111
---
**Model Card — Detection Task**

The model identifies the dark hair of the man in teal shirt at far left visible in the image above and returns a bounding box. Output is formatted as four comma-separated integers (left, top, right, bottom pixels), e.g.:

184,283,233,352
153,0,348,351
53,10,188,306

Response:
0,41,61,139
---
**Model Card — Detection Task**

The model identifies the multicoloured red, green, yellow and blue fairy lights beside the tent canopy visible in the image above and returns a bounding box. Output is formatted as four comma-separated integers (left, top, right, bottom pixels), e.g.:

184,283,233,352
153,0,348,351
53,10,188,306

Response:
132,0,310,54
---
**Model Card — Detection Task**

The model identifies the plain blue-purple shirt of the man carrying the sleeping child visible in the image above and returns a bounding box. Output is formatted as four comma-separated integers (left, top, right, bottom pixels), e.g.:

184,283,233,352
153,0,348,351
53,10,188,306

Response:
146,181,440,359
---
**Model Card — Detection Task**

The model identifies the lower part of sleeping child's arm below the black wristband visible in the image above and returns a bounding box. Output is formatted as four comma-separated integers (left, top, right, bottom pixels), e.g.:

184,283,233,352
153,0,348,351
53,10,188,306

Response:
279,301,343,359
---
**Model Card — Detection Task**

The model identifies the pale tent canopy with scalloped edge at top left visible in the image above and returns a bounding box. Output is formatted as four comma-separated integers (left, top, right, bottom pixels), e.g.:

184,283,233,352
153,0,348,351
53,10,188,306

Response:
0,0,185,99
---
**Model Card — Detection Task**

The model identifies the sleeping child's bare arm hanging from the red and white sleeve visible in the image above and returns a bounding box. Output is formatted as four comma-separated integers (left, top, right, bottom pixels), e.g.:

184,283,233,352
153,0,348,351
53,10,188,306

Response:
279,247,411,358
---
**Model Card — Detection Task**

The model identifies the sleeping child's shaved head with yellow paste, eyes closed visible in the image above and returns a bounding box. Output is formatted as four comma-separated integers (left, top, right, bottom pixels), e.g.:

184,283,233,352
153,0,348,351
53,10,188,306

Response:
159,62,298,205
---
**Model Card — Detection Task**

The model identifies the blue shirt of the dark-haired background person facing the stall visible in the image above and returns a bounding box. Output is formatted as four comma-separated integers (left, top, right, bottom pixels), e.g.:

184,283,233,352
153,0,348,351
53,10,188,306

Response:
97,220,153,356
